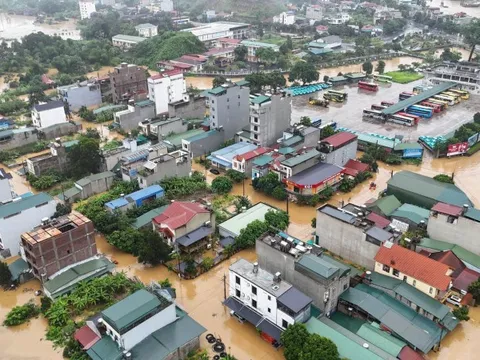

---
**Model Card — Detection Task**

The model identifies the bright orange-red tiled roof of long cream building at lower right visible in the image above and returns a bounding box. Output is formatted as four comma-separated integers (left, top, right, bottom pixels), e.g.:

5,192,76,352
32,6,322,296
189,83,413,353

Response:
375,244,451,290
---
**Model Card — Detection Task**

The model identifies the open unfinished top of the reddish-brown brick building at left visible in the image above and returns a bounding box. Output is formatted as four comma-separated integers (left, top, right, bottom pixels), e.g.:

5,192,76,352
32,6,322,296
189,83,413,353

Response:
22,210,91,245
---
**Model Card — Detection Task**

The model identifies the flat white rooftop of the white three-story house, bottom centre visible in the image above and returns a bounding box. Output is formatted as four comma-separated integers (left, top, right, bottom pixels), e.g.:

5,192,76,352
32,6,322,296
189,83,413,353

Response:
230,259,292,298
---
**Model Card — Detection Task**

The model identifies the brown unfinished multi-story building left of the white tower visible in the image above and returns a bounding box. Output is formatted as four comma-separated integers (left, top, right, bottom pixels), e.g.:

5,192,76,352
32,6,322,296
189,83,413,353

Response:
109,63,148,104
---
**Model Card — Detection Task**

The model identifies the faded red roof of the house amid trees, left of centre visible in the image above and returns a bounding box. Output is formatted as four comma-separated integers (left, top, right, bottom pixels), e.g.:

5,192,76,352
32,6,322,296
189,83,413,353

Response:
153,201,209,230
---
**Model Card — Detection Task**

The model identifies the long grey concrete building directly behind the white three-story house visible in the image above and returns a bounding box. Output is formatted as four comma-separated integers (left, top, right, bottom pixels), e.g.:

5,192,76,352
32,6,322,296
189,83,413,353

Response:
255,233,351,316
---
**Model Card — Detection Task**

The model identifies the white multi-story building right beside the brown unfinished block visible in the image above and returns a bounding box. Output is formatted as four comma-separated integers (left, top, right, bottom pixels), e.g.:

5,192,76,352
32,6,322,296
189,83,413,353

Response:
148,70,187,115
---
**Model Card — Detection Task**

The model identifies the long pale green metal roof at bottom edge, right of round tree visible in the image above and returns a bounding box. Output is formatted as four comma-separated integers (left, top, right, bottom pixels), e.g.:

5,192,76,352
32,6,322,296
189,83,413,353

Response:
305,318,382,360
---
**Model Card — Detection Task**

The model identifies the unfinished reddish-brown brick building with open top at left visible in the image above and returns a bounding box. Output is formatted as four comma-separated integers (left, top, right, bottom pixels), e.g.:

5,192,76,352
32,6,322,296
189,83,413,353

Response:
20,211,97,282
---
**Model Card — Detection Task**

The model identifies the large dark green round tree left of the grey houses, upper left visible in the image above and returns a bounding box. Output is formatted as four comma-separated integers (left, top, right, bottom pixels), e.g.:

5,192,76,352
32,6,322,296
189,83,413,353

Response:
67,136,102,178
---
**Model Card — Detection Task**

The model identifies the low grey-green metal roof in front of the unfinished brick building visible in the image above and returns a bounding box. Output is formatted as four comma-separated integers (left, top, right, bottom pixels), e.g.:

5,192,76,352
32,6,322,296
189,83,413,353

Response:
43,257,115,298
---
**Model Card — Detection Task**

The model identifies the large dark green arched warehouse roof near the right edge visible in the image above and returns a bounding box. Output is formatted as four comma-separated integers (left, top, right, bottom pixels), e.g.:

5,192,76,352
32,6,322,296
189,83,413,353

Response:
387,171,473,208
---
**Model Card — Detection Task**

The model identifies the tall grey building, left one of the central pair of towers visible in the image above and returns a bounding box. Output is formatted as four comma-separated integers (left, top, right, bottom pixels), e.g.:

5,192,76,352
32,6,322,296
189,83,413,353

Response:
206,81,250,141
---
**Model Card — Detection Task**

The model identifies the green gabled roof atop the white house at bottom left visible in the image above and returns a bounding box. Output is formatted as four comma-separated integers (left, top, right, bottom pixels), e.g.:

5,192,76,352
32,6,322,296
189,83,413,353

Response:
102,289,161,332
